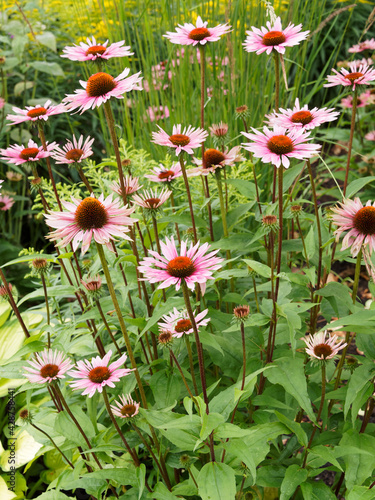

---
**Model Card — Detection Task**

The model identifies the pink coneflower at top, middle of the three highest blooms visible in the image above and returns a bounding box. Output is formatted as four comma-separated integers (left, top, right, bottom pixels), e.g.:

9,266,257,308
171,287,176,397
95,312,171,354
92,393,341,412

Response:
163,16,231,45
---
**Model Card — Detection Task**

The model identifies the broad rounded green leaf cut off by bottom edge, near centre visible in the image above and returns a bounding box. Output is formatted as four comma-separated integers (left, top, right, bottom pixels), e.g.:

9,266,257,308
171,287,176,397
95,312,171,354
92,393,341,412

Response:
197,462,236,500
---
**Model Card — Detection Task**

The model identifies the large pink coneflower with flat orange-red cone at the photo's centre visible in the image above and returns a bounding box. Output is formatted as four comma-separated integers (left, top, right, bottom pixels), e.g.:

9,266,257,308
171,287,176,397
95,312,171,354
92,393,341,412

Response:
138,237,223,294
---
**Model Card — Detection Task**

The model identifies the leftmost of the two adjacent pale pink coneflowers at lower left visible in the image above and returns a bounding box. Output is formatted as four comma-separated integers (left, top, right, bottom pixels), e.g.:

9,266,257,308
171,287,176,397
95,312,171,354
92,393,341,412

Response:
23,349,73,384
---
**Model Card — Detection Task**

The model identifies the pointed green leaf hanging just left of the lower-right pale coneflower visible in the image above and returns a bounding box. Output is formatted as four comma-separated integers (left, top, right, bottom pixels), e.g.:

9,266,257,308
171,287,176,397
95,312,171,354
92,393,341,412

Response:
267,357,315,422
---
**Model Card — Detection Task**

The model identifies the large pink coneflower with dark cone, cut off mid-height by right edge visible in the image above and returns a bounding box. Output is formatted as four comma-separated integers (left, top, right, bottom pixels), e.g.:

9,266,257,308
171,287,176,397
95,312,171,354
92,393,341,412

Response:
331,198,375,257
